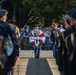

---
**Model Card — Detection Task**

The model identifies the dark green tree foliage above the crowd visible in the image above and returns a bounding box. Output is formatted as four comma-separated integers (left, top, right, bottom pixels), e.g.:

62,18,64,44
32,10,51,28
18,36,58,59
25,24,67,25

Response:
15,0,76,27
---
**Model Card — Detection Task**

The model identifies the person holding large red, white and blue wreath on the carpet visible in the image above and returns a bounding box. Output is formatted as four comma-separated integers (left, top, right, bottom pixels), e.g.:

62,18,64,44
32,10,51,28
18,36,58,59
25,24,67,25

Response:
30,25,45,58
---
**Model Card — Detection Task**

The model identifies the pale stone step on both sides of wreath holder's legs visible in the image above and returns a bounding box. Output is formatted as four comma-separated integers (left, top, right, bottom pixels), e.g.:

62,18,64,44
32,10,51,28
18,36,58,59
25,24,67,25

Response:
20,50,53,58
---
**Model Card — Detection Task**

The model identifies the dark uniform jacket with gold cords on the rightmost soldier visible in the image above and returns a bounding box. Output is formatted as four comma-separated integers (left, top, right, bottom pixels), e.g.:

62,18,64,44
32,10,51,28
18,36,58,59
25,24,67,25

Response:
63,31,76,75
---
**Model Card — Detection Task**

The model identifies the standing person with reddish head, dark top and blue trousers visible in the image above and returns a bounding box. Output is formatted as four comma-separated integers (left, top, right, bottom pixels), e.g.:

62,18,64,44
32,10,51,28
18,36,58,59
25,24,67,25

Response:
51,23,60,58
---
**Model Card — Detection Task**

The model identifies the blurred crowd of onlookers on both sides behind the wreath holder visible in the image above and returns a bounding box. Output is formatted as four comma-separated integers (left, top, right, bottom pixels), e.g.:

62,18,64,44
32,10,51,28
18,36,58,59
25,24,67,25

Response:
20,23,65,50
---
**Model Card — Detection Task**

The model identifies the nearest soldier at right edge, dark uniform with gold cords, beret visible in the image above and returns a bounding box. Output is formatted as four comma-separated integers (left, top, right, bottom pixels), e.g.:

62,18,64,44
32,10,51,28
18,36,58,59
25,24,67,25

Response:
63,10,76,75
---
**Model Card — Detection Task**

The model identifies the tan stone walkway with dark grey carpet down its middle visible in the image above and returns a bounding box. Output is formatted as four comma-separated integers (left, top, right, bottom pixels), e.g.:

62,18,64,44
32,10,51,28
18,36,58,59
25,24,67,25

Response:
14,51,60,75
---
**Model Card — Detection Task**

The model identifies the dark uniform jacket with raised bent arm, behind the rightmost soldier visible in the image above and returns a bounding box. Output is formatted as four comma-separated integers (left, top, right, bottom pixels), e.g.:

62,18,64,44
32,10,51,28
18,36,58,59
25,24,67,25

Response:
57,25,75,71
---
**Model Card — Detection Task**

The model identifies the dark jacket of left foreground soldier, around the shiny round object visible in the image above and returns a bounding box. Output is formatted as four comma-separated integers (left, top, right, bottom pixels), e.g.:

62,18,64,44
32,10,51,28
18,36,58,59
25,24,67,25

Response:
0,21,19,70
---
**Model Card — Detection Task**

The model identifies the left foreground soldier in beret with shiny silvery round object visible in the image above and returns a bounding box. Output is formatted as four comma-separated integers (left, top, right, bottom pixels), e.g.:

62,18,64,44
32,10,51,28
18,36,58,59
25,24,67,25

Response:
0,9,19,75
